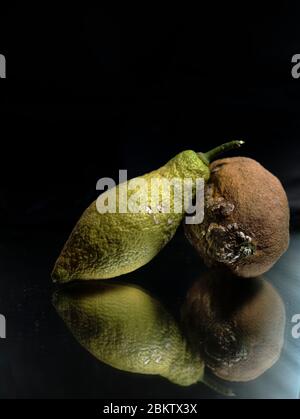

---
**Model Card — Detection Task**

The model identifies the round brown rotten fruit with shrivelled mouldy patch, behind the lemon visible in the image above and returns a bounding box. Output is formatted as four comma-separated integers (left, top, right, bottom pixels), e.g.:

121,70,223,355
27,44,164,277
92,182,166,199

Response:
185,157,289,277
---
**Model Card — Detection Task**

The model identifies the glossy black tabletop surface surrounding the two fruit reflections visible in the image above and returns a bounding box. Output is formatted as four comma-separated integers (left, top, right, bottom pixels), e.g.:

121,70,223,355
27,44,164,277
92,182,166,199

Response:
0,229,300,399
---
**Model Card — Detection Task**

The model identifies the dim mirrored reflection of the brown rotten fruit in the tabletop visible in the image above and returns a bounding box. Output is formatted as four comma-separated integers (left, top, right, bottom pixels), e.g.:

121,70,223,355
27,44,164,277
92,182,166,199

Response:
182,272,285,381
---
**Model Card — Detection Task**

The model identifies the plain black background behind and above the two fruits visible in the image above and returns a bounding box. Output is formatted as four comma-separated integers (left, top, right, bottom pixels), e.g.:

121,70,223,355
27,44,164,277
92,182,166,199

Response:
0,4,300,230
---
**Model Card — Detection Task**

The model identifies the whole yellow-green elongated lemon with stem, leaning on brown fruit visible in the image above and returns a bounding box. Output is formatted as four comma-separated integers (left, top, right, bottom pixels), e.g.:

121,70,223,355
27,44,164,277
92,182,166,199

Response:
52,141,242,282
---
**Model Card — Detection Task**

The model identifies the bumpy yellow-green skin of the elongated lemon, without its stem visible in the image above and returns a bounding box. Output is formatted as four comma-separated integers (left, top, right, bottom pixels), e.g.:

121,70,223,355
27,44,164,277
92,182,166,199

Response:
52,150,209,282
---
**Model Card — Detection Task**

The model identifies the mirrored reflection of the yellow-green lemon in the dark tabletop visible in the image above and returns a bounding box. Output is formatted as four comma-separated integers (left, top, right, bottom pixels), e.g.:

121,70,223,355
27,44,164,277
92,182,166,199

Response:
54,283,204,386
